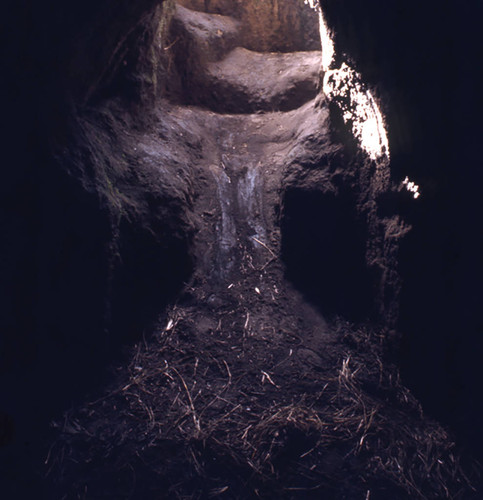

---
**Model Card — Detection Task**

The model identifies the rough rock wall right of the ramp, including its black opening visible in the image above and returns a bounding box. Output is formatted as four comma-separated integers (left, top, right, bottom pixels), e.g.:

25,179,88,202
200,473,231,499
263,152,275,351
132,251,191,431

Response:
281,104,410,328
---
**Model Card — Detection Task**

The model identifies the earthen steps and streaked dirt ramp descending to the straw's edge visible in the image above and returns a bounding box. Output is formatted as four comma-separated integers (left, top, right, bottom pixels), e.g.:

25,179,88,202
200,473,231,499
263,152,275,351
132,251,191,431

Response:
153,0,333,378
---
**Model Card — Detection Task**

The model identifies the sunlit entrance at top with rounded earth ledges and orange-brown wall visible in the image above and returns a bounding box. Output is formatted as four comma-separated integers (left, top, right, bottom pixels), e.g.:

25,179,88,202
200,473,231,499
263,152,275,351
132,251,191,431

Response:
168,0,320,113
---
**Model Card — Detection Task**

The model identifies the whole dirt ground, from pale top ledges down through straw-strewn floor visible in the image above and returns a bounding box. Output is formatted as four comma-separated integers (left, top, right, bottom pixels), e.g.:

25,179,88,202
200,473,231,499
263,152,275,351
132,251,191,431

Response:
46,1,481,500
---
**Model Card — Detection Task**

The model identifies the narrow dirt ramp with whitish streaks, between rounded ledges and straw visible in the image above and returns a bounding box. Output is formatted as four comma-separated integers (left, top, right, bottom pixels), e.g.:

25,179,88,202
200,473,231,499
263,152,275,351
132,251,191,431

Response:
155,95,336,388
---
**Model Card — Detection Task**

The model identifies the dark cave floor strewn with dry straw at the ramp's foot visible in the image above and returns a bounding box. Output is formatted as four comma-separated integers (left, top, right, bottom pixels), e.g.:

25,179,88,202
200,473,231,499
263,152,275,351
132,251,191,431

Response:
48,316,477,499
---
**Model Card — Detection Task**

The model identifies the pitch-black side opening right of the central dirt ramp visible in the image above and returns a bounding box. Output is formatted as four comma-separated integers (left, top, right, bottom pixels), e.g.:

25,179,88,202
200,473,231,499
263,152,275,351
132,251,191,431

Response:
281,189,374,321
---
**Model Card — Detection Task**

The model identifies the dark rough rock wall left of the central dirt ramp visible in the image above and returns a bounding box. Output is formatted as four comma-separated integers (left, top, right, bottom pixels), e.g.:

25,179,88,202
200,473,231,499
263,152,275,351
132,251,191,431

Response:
0,1,195,479
